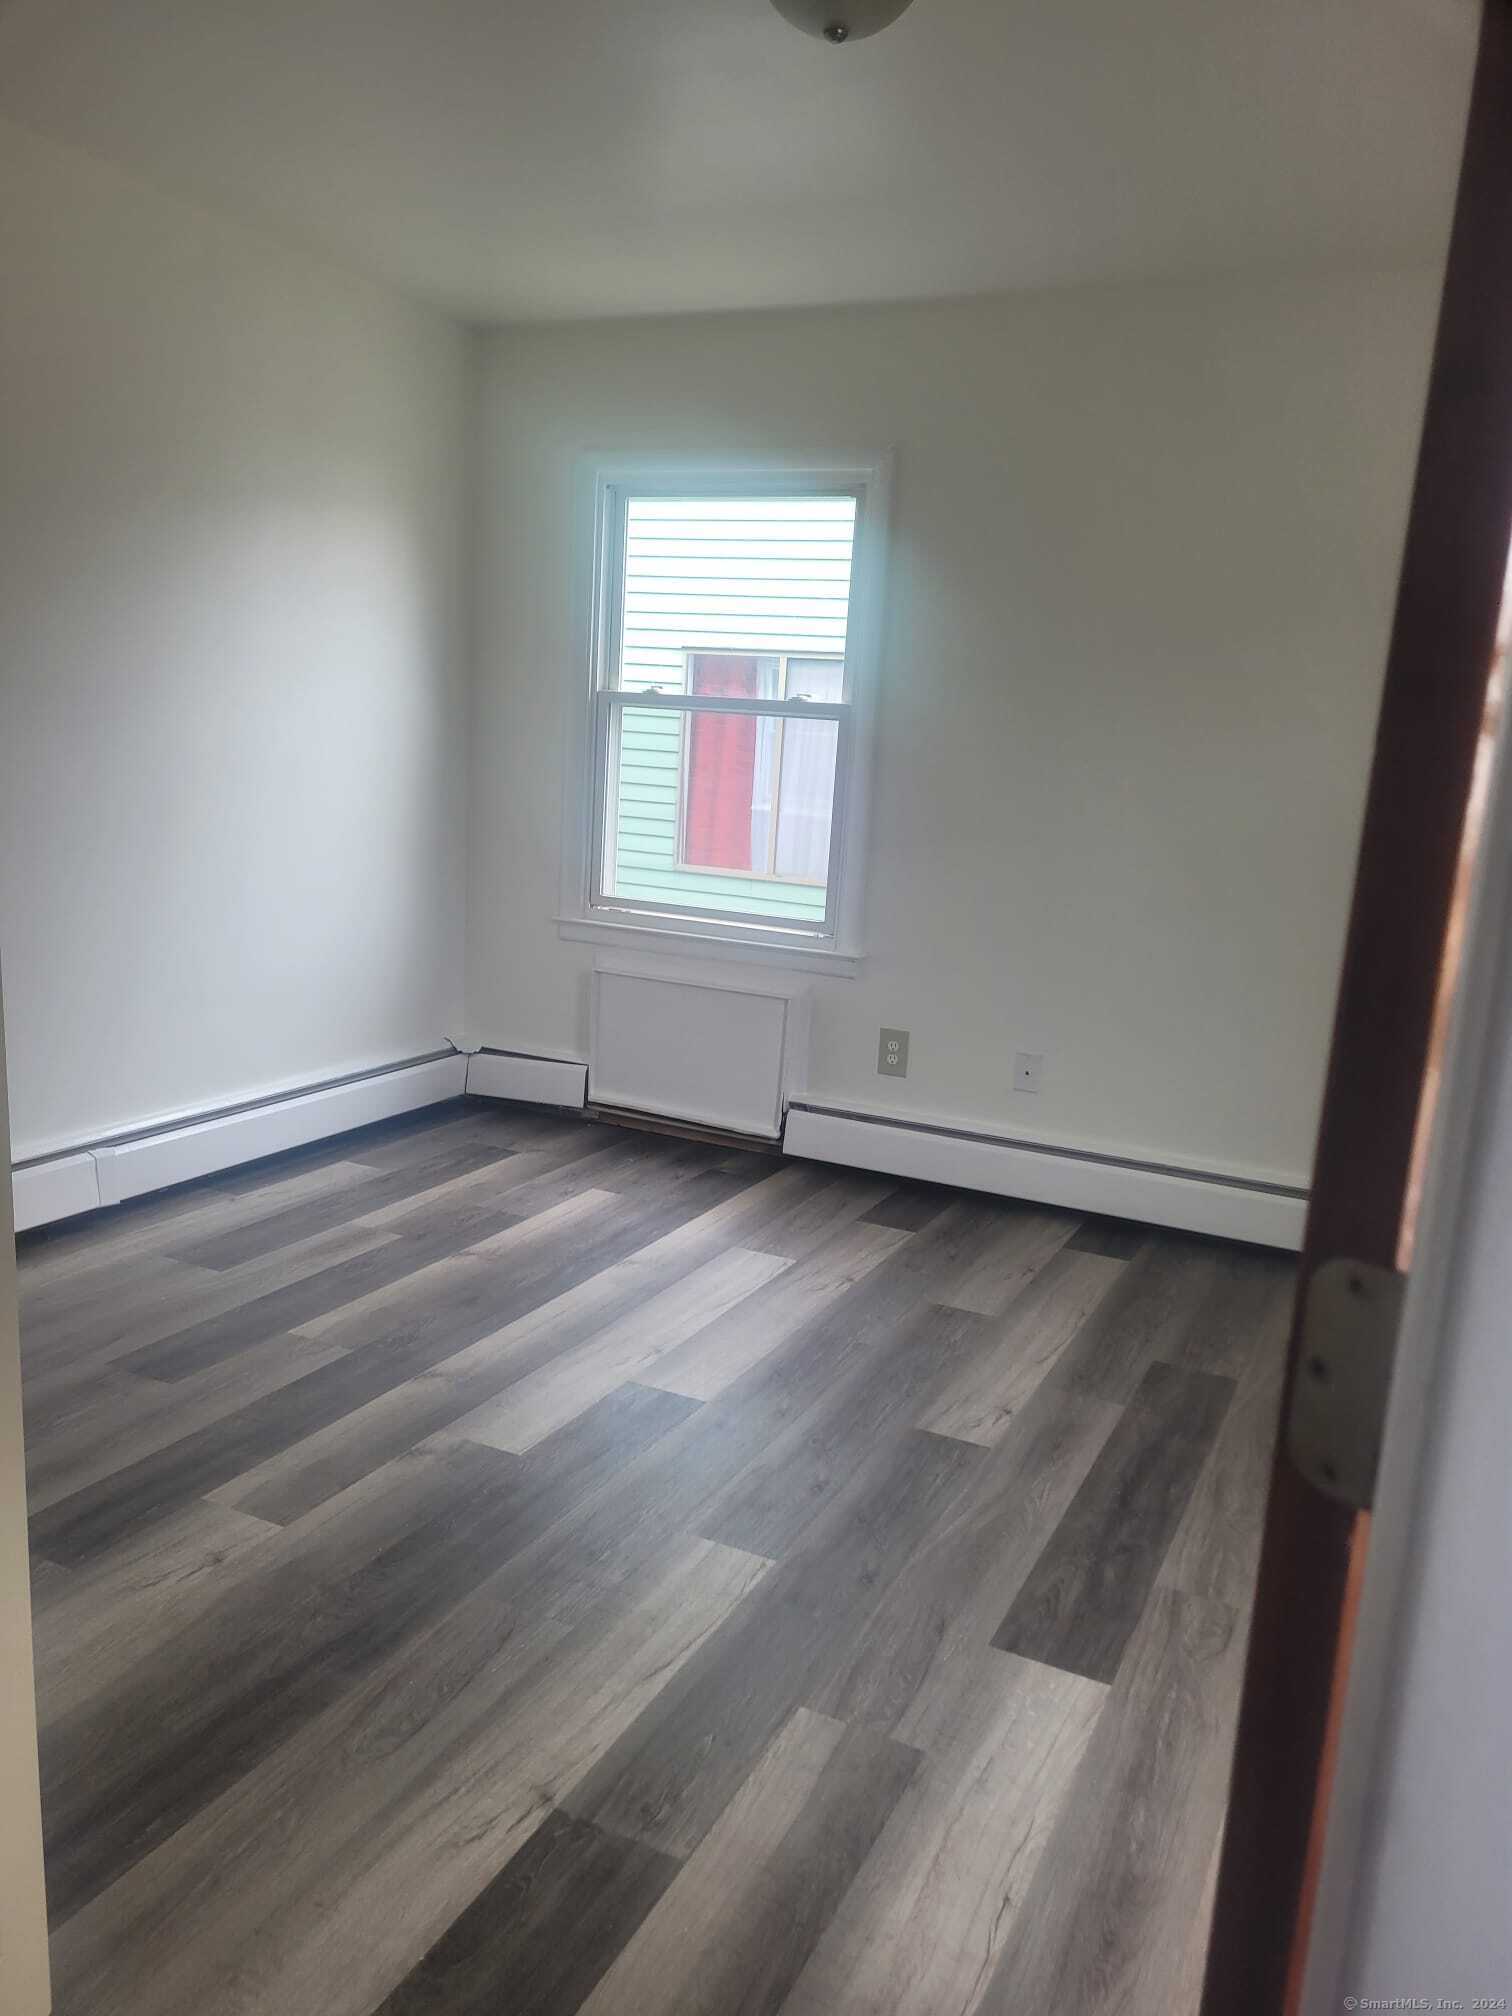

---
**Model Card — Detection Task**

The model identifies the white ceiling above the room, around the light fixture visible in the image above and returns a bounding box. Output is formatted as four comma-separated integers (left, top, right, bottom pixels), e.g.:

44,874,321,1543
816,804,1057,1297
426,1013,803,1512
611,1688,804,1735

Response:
0,0,1476,319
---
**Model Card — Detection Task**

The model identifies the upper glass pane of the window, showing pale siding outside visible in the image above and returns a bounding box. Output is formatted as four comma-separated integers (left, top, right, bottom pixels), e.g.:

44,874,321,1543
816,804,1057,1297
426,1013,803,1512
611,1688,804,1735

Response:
615,496,855,700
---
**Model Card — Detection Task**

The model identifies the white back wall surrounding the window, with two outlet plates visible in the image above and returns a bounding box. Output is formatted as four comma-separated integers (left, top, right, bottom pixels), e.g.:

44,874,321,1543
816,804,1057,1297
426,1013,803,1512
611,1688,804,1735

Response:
468,270,1437,1181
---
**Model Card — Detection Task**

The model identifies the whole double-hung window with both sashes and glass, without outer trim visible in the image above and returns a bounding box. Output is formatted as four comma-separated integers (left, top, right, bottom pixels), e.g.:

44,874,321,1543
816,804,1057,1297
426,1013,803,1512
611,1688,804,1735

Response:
569,472,895,958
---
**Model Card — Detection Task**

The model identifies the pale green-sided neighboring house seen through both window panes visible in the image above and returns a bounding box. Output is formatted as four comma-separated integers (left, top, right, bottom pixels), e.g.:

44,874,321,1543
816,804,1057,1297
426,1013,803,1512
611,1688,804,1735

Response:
605,496,855,921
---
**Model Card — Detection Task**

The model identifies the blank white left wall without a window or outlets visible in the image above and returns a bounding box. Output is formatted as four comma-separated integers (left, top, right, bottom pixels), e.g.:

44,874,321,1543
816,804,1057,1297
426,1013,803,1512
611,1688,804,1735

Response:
0,125,470,1157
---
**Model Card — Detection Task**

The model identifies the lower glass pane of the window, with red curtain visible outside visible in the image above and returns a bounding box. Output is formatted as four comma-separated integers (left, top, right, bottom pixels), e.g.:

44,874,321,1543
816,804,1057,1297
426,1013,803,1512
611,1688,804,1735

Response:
603,708,839,925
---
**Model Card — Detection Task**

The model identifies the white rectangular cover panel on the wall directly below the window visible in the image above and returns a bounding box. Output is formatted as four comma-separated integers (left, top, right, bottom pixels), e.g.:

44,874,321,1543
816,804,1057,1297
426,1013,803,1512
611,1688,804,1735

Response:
589,956,808,1141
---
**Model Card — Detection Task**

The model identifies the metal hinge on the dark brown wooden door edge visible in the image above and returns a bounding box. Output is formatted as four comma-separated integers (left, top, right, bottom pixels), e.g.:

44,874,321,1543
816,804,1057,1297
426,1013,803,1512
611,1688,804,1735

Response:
1286,1260,1407,1512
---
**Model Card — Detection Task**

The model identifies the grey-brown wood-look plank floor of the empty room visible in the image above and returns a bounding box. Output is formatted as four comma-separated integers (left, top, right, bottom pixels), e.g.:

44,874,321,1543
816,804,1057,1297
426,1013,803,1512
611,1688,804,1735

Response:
20,1101,1292,2016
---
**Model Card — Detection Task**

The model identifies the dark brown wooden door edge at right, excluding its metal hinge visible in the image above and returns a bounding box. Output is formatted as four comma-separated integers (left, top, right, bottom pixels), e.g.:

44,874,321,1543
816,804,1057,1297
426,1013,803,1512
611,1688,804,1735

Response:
1202,0,1512,2016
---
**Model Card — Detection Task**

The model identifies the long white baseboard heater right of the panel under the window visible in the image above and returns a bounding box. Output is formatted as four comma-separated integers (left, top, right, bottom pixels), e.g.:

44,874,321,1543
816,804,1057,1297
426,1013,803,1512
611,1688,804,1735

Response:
782,1105,1306,1252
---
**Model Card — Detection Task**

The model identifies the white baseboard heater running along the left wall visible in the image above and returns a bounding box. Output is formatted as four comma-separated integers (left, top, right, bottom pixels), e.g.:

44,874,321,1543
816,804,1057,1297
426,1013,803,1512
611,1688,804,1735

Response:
10,1052,468,1232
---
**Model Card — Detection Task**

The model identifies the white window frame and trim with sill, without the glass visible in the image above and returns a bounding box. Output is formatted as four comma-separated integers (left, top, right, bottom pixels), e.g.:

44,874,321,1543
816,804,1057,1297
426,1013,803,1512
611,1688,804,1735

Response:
556,456,891,974
